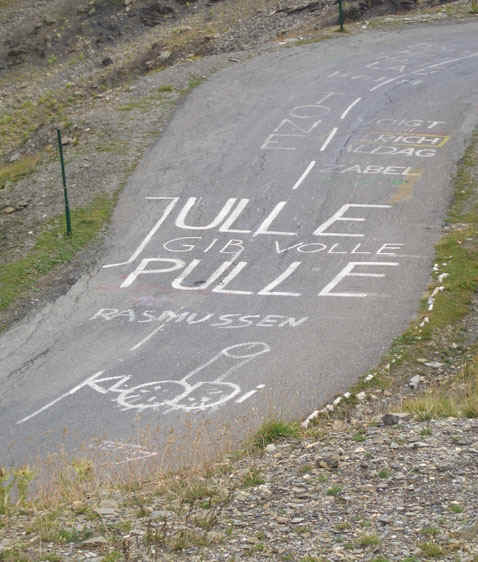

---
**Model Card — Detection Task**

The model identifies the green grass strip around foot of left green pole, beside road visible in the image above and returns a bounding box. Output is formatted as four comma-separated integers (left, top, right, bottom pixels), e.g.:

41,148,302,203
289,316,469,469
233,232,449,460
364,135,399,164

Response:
0,195,116,320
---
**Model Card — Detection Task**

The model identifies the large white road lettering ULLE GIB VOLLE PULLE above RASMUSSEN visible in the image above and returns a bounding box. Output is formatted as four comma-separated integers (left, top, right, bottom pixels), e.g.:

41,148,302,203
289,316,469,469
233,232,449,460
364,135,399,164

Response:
105,197,401,298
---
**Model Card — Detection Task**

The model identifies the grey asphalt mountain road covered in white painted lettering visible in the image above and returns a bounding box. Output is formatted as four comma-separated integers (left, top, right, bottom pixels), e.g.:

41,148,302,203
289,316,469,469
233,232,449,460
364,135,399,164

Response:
0,21,478,464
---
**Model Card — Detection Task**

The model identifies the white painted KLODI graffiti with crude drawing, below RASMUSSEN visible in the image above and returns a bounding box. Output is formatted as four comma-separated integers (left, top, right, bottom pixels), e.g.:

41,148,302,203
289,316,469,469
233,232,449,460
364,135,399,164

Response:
17,342,271,424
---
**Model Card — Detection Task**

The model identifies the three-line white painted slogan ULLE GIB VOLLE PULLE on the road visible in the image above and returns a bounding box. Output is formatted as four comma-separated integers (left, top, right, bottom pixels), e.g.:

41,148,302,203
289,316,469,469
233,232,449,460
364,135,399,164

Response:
104,197,402,298
